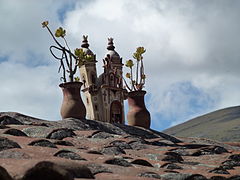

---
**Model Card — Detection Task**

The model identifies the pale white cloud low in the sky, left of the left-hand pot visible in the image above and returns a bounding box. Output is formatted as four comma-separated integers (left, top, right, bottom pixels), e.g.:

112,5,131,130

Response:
0,62,61,120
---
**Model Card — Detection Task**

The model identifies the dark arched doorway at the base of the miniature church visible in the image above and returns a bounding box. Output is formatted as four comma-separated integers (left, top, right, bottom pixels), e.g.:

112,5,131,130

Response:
110,101,123,124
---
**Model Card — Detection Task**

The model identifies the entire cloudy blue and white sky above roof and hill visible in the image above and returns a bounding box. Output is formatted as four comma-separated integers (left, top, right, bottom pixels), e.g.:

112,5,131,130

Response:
0,0,240,130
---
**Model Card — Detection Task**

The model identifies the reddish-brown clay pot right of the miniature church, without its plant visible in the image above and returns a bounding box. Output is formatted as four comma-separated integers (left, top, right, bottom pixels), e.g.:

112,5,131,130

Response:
127,91,151,129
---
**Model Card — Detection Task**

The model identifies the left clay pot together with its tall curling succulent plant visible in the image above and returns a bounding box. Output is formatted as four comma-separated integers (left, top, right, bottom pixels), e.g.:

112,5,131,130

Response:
41,21,86,119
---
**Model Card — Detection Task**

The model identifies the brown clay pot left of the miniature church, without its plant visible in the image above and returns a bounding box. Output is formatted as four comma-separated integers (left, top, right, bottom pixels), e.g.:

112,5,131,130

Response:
59,82,86,119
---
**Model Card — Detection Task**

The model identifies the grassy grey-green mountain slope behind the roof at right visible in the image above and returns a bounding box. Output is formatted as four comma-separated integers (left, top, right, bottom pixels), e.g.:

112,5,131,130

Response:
163,106,240,142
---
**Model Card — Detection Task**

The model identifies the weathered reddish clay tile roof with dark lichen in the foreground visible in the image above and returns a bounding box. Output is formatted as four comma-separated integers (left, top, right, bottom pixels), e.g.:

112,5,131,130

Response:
0,113,240,180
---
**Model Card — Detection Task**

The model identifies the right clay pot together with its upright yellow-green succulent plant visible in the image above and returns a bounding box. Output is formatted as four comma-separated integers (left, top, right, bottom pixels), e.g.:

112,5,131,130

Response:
123,47,151,129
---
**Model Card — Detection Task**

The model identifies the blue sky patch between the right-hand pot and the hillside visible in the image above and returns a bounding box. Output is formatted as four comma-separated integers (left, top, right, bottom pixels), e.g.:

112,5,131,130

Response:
145,81,217,131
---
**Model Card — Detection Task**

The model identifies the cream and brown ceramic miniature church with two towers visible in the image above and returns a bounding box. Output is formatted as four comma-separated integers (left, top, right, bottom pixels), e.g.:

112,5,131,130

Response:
80,36,126,124
